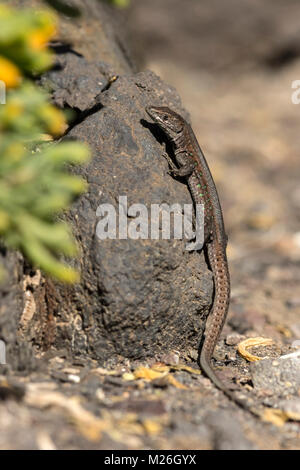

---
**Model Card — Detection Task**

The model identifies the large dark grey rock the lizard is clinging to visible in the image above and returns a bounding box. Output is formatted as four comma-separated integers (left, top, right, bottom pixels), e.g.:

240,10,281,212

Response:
47,72,213,362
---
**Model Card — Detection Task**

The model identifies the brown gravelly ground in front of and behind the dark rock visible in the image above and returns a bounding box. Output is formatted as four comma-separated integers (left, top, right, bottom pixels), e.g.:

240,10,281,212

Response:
0,0,300,449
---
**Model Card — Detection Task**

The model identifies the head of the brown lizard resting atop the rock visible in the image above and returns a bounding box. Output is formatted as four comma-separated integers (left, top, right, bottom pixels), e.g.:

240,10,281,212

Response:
146,106,184,139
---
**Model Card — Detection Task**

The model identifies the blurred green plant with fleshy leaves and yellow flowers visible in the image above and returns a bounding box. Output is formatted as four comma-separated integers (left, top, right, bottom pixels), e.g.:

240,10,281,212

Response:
0,5,89,282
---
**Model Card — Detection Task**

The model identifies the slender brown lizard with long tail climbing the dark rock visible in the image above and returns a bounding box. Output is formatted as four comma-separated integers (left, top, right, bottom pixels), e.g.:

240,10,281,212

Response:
146,106,260,416
